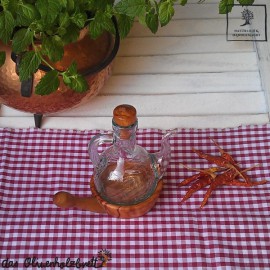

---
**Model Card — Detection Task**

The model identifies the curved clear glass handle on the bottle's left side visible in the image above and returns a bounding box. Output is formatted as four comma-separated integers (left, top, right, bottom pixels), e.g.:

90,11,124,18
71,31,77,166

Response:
88,133,113,167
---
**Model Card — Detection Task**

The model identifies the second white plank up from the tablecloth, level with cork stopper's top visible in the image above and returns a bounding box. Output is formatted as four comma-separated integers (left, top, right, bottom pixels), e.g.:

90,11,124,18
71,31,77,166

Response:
1,92,267,117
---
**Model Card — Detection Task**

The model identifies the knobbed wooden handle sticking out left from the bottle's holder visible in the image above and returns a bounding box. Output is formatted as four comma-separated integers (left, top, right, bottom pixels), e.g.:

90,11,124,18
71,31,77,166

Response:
53,191,106,213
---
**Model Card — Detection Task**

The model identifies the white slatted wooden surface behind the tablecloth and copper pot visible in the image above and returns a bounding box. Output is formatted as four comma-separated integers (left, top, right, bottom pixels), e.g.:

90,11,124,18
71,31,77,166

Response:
0,0,270,129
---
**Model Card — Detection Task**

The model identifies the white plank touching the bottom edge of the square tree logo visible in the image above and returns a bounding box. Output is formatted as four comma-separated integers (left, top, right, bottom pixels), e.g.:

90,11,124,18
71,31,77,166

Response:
118,35,254,56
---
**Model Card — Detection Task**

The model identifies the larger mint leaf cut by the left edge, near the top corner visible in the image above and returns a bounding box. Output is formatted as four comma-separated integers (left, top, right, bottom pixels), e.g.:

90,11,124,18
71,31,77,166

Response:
0,10,15,44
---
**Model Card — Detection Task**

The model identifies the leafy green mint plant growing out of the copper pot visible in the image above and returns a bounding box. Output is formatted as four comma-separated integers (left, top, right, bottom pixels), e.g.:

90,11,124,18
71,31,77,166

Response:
0,0,254,95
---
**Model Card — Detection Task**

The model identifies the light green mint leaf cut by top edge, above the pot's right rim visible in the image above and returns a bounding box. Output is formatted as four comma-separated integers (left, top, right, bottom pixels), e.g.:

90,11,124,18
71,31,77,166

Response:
115,0,145,17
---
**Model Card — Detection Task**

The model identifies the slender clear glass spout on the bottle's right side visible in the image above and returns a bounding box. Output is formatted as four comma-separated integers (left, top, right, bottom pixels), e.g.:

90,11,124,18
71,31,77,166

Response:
152,129,177,179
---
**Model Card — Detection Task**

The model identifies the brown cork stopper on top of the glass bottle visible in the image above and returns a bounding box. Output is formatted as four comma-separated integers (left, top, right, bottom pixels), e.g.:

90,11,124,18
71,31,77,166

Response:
113,104,137,127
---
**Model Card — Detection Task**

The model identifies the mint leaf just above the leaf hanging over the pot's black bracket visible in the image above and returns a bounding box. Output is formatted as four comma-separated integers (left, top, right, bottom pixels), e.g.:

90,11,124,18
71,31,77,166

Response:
12,28,34,53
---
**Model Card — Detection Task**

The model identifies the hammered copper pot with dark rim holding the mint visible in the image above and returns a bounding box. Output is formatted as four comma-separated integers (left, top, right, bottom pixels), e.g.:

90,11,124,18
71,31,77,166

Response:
0,21,119,115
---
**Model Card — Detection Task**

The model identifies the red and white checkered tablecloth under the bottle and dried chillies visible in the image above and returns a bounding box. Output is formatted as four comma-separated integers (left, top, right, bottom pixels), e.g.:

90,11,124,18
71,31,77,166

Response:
0,125,270,269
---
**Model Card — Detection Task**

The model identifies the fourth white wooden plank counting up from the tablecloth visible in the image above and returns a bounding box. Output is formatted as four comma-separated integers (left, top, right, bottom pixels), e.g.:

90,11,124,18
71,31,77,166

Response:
113,52,258,75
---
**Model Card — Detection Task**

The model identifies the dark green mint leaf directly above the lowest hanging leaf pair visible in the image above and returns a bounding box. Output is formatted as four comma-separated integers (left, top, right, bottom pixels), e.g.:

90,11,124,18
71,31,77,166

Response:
42,36,64,62
